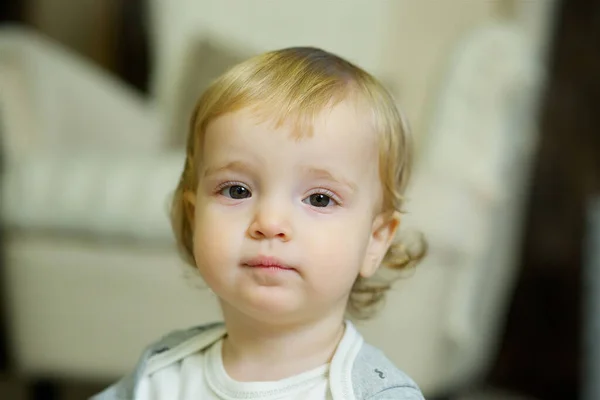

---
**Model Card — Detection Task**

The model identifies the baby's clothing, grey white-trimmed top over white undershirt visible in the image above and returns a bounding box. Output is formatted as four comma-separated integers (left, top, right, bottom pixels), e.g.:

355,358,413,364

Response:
92,321,423,400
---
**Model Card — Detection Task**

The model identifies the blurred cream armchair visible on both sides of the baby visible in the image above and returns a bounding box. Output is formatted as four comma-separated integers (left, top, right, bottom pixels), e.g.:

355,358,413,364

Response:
0,16,539,396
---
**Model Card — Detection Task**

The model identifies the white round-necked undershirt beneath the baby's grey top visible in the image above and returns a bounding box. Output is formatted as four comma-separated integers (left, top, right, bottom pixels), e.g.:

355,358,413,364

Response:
136,324,360,400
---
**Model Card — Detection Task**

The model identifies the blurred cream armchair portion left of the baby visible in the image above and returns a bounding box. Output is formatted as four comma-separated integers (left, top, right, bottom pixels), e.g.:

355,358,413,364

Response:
0,28,223,380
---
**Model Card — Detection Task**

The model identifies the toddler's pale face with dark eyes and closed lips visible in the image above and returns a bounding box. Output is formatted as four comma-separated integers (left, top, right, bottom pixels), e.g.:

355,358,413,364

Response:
194,101,387,320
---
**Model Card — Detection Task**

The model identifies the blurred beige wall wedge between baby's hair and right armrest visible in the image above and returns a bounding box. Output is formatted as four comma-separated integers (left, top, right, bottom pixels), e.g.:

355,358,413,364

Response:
377,0,502,147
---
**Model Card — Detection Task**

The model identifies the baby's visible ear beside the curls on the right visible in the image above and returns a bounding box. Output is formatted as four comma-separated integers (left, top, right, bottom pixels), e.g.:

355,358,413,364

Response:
360,211,400,278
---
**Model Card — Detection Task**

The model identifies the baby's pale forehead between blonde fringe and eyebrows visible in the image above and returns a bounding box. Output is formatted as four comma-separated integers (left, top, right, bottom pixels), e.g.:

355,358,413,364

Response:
202,102,380,179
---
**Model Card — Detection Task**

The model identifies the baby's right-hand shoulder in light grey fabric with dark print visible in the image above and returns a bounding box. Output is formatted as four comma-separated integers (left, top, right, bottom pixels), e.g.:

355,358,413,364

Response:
352,343,423,400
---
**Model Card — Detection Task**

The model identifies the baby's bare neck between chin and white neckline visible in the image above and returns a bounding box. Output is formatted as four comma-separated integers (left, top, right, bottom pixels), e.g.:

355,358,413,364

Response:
223,315,344,382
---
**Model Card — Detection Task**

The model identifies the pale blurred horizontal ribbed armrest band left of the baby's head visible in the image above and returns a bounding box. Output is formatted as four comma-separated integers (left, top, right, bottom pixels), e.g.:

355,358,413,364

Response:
2,152,184,242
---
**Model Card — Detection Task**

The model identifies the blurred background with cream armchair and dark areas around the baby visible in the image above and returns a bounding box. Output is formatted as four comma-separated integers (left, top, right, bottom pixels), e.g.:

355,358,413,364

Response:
0,0,600,400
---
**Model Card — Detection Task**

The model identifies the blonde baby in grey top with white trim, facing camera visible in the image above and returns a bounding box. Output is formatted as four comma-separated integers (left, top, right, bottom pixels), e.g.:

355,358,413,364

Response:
95,48,423,400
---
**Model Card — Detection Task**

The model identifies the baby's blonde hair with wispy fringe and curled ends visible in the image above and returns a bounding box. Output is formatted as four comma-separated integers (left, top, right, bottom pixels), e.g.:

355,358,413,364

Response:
171,47,425,318
